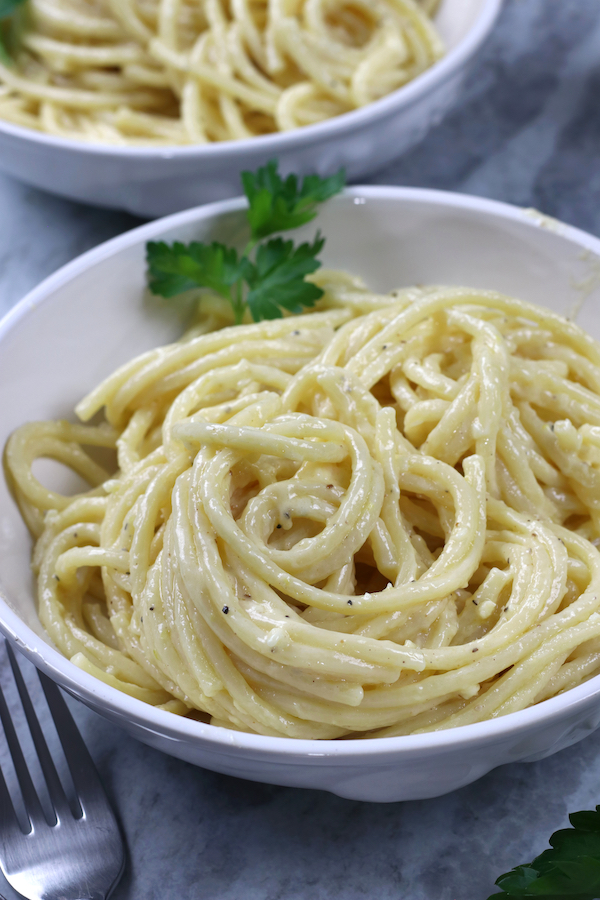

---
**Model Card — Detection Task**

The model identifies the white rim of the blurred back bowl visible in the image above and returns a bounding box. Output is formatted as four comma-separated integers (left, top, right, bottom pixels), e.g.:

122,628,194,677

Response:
0,0,503,162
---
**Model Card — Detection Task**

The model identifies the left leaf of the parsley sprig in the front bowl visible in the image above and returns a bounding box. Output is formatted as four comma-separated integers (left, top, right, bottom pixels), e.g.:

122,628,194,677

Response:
146,241,241,300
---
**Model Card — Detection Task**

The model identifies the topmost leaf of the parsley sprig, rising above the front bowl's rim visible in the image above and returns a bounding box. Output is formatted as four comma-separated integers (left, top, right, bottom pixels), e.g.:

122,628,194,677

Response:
242,160,346,241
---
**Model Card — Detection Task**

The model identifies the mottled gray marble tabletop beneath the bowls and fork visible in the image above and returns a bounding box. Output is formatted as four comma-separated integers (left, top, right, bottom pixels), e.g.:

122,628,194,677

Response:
0,0,600,900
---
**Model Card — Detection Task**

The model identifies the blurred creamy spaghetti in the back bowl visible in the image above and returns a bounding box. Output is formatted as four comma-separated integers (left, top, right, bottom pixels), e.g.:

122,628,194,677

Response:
0,0,442,145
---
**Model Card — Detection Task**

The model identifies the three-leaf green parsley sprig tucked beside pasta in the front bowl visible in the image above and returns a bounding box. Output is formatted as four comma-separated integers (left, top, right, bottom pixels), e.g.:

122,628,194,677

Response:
146,160,345,324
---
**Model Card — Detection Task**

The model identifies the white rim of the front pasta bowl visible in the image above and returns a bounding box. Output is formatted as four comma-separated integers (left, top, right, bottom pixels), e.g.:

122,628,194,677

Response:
0,186,600,764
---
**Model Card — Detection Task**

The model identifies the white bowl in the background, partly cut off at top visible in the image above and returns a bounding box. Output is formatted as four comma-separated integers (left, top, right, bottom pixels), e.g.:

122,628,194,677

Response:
0,0,502,217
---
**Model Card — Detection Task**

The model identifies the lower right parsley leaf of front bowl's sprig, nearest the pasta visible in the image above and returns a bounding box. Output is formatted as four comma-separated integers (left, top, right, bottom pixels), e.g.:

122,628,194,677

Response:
244,234,325,322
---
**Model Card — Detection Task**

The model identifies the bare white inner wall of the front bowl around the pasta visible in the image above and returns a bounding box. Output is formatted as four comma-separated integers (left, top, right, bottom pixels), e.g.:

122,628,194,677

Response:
0,188,600,712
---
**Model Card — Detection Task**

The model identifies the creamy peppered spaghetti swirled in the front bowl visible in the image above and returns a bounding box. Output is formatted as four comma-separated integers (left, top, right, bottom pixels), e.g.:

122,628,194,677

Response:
5,270,600,739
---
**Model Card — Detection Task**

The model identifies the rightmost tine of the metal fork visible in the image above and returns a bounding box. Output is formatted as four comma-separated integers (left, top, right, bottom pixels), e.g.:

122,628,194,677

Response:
38,671,109,814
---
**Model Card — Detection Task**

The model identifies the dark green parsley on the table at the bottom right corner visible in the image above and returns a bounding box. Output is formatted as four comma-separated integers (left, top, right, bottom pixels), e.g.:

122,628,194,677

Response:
489,806,600,900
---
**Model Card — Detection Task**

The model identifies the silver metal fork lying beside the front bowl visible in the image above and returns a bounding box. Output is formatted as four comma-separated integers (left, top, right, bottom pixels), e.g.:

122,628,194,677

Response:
0,643,125,900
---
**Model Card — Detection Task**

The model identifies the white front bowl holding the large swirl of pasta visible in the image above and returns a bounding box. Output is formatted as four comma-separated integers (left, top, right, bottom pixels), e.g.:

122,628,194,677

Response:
0,187,600,801
